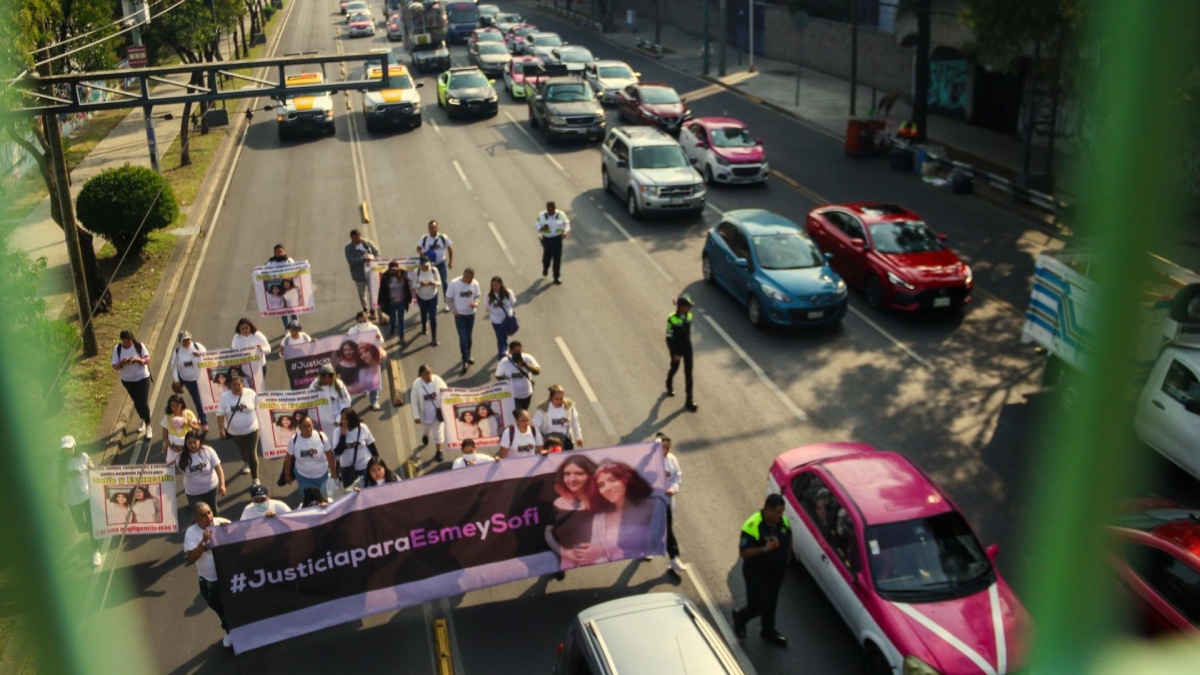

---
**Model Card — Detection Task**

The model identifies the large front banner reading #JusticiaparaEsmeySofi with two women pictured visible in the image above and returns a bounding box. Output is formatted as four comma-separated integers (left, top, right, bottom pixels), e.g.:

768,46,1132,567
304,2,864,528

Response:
212,443,667,653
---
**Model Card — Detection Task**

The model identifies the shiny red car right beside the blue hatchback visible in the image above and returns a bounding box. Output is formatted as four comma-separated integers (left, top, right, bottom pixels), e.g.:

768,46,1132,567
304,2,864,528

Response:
804,202,974,311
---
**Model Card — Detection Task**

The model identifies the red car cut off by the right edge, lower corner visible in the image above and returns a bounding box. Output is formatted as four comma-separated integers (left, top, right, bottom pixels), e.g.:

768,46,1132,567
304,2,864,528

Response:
1110,500,1200,638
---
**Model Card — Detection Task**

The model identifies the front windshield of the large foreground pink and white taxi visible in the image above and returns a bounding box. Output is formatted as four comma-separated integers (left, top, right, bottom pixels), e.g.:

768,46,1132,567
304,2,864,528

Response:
866,510,995,602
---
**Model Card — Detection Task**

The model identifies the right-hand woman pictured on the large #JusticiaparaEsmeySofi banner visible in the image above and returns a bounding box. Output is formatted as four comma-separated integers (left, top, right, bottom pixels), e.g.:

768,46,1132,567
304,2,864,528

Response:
587,461,667,565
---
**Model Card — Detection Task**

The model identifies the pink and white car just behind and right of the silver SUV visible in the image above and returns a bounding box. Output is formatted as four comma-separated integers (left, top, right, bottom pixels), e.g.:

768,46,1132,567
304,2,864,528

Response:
679,118,770,184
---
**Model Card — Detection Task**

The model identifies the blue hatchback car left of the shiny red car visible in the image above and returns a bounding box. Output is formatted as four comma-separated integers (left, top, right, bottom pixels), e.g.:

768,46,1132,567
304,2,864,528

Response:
703,209,850,327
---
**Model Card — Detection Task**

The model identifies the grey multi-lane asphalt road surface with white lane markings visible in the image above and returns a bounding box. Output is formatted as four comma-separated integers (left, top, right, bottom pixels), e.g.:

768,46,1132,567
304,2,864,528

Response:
79,0,1147,674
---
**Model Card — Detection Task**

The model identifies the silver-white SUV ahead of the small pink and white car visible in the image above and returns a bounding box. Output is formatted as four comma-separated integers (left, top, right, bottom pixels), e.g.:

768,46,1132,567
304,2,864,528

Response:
600,126,707,217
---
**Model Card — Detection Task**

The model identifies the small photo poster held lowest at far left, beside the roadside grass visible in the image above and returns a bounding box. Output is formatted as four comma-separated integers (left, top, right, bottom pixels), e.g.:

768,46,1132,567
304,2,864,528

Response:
88,464,179,538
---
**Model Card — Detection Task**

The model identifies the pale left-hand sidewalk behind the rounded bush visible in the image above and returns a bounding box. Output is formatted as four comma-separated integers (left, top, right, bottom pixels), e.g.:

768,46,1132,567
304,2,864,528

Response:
8,103,184,317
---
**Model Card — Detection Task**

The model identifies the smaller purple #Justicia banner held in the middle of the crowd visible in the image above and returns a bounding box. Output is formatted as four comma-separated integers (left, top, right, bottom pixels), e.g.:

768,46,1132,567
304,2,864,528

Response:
283,333,384,394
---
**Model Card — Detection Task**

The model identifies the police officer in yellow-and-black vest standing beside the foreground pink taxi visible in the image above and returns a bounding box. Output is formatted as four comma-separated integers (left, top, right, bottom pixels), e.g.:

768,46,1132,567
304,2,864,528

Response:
733,495,792,647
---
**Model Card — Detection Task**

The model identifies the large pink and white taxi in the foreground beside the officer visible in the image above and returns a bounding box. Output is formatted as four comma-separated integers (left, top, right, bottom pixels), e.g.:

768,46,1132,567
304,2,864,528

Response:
768,443,1031,675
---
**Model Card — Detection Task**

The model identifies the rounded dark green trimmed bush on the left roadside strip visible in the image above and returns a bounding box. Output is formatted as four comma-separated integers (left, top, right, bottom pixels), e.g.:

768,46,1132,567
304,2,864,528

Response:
76,165,179,253
